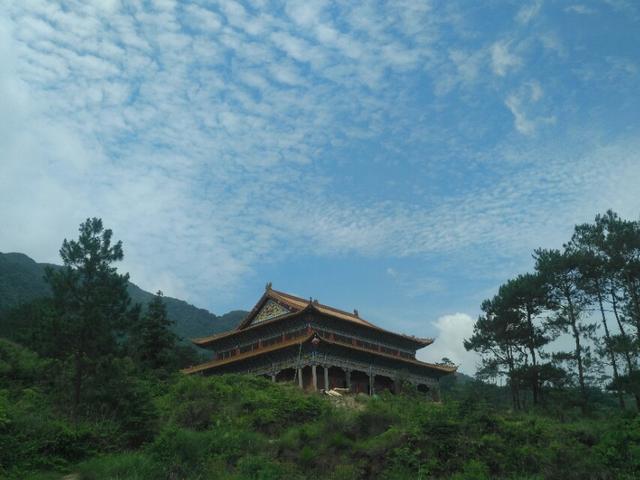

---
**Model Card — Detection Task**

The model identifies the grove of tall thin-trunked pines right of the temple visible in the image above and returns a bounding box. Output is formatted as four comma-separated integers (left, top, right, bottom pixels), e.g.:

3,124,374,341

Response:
464,211,640,413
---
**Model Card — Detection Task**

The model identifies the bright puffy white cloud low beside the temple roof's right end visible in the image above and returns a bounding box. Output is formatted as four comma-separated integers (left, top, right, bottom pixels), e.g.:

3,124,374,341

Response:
418,313,480,375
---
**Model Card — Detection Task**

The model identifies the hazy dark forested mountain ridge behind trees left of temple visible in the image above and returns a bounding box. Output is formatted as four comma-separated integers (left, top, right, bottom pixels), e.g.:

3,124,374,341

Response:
0,253,248,338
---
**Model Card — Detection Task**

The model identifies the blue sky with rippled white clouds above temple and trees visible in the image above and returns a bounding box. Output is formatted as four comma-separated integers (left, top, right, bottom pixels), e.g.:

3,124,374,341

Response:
0,0,640,373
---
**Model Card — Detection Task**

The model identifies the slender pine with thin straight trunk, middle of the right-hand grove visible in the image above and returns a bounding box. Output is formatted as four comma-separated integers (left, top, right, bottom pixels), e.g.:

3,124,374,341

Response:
534,248,596,411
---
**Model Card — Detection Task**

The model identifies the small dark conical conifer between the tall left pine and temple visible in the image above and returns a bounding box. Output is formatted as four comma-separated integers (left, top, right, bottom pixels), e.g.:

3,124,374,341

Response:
132,291,177,370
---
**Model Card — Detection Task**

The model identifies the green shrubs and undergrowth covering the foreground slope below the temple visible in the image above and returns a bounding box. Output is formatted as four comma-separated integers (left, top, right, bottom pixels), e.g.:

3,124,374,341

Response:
0,341,640,479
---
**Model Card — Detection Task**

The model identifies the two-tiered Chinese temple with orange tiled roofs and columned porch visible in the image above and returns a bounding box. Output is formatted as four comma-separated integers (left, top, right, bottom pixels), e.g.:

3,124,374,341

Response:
184,284,456,399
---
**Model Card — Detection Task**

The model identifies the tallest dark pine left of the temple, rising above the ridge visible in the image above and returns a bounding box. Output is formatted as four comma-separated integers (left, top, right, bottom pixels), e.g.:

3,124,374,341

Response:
45,218,131,416
